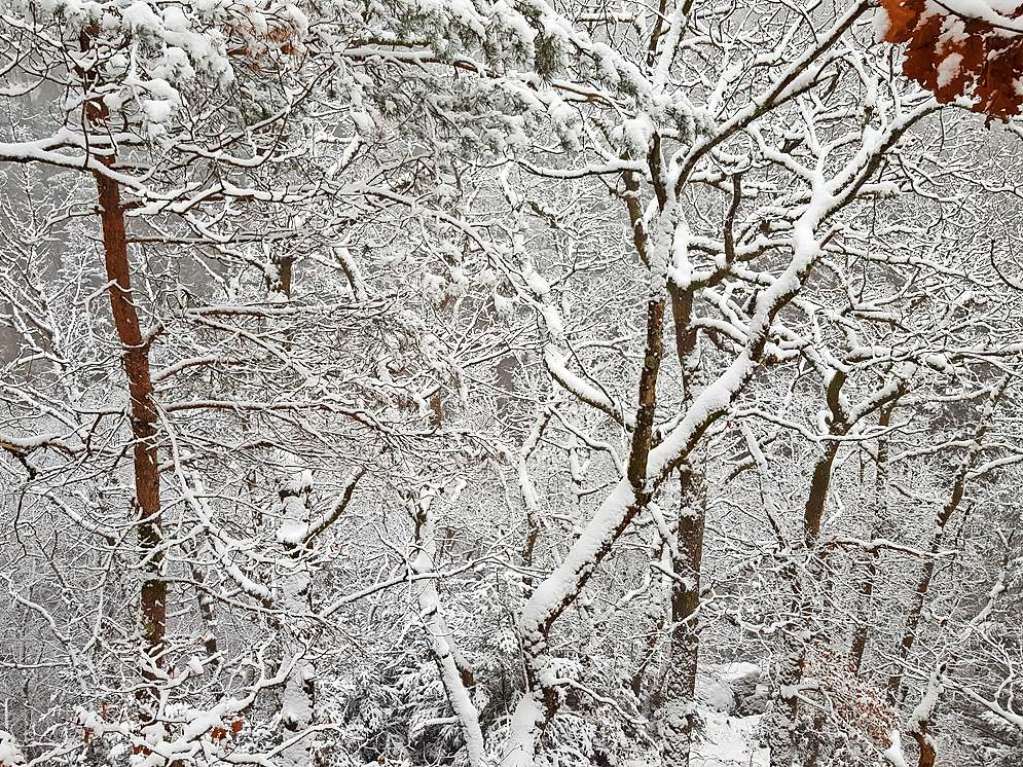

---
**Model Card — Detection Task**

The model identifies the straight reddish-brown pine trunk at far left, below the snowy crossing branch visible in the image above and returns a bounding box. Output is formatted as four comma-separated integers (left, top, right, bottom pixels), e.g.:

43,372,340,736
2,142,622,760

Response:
94,172,167,695
